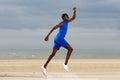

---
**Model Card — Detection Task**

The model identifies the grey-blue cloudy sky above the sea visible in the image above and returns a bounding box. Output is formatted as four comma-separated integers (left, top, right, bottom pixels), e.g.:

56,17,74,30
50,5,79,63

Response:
0,0,120,50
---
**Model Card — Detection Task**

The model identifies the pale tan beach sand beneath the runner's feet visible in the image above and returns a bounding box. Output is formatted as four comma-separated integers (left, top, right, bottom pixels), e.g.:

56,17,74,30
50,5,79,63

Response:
0,59,120,80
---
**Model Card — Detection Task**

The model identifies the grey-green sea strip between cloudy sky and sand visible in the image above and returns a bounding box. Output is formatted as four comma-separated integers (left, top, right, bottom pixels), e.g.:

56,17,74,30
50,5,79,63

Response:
0,49,120,59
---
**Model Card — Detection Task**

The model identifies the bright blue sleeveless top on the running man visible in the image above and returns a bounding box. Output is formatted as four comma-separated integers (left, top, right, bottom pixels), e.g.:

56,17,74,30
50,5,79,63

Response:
56,21,68,39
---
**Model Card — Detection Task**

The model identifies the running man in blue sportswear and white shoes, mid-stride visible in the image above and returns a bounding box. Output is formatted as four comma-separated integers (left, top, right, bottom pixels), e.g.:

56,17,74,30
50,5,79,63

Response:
41,7,76,76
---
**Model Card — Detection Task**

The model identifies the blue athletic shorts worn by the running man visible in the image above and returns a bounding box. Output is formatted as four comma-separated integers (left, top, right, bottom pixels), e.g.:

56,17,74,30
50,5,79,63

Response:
53,39,69,49
